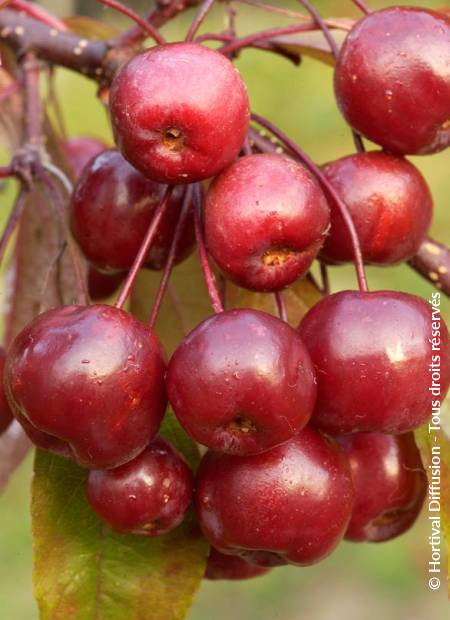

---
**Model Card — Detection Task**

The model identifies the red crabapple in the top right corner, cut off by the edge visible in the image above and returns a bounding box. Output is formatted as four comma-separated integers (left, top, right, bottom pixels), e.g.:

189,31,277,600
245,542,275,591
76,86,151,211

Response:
335,7,450,155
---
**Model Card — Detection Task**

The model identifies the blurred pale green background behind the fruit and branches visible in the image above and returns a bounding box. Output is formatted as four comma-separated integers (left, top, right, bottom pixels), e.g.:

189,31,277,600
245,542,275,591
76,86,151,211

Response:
0,0,450,620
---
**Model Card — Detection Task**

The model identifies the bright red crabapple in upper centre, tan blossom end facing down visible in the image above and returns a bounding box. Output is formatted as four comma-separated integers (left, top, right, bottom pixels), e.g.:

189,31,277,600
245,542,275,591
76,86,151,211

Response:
205,154,329,291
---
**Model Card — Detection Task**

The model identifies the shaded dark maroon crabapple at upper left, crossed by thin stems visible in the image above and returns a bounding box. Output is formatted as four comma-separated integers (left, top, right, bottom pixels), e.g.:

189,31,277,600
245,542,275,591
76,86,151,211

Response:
70,149,195,271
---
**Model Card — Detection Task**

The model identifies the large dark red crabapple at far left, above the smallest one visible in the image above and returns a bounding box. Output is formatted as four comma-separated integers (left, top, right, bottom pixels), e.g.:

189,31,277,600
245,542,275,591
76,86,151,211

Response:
5,305,166,468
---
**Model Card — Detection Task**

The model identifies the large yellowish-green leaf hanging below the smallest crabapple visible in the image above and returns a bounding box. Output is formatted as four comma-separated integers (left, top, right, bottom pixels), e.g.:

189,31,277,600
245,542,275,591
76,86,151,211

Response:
32,415,208,620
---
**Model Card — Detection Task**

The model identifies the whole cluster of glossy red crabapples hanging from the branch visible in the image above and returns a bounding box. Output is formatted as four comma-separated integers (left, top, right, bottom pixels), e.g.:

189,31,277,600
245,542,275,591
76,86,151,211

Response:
0,8,450,579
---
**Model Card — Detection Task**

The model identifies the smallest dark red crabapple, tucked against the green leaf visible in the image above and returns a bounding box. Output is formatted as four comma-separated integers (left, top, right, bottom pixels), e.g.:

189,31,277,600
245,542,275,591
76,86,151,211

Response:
86,438,193,536
